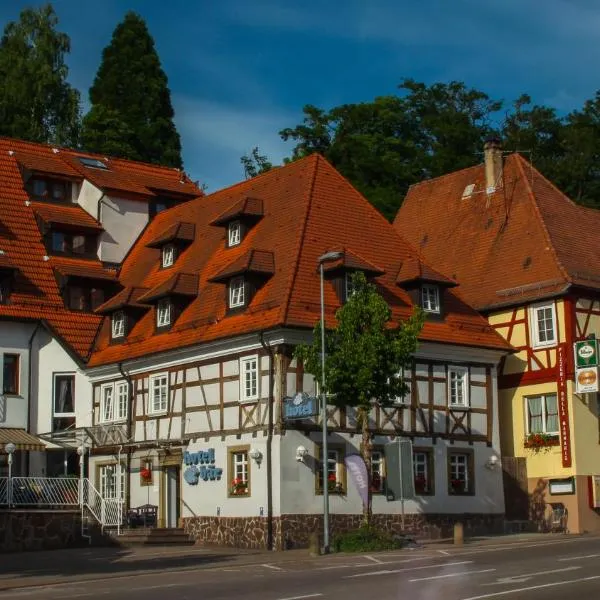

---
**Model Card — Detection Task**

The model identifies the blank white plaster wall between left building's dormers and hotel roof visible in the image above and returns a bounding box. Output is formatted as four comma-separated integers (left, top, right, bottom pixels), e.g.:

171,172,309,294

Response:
98,196,148,263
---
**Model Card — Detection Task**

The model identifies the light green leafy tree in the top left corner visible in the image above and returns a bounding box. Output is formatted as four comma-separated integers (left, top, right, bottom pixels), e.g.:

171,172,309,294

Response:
0,4,80,146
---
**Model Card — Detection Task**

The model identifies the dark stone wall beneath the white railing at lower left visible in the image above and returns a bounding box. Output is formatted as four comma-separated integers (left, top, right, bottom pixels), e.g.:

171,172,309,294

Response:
0,510,95,552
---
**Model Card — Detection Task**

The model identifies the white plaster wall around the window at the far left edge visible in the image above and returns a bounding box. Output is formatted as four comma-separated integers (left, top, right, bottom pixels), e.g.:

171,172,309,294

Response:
0,321,35,429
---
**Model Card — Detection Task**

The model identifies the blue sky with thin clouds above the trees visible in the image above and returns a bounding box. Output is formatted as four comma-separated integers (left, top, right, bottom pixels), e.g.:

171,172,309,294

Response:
0,0,600,191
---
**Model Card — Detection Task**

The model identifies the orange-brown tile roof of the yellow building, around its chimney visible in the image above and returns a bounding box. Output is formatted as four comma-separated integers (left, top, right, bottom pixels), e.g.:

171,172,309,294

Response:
394,154,600,309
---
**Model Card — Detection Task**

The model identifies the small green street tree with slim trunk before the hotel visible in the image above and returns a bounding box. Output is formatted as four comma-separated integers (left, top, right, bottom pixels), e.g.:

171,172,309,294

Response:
295,272,424,524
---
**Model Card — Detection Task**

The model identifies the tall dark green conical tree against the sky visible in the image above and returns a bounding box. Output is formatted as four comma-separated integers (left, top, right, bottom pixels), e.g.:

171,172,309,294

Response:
82,12,182,168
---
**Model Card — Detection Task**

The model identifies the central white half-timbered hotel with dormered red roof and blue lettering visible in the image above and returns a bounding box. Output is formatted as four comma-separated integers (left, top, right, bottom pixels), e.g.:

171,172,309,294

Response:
88,155,511,548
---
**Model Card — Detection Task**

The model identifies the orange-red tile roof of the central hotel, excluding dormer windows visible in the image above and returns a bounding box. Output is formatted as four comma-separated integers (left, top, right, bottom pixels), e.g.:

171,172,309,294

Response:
90,155,510,366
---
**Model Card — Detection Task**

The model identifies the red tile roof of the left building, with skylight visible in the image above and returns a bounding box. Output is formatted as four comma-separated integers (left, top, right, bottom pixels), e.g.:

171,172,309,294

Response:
0,137,201,362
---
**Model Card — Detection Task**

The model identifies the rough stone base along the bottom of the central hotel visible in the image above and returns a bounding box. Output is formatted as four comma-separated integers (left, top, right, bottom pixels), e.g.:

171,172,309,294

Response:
182,514,504,550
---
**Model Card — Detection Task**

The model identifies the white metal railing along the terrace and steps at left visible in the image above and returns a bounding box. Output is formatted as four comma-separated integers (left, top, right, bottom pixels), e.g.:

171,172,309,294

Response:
0,477,123,529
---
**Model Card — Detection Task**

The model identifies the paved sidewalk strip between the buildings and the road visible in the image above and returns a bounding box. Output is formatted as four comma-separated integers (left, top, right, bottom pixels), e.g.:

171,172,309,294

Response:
0,533,593,592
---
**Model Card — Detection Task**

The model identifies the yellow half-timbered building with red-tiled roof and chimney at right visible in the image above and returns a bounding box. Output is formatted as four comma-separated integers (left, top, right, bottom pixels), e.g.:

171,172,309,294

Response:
394,140,600,532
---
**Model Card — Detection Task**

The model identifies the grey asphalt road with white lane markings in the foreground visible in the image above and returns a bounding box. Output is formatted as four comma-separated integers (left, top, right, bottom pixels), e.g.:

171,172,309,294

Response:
0,537,600,600
